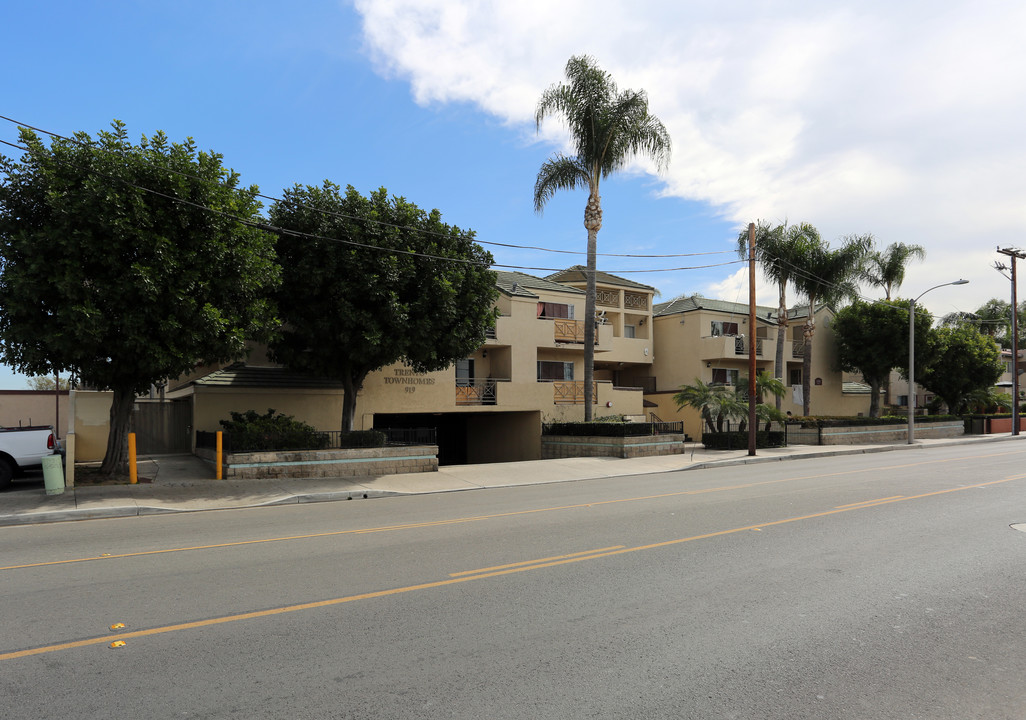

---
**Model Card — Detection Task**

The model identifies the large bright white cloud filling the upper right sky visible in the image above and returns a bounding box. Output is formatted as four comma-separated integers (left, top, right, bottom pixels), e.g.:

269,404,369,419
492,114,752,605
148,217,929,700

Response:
355,0,1026,312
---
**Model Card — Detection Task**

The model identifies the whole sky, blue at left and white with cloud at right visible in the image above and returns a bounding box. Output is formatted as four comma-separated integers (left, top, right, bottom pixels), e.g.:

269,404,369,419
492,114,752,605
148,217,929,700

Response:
0,0,1026,389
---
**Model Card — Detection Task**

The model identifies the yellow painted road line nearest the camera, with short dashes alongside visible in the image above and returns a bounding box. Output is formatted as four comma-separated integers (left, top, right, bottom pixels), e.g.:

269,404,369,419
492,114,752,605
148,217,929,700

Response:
0,474,1026,662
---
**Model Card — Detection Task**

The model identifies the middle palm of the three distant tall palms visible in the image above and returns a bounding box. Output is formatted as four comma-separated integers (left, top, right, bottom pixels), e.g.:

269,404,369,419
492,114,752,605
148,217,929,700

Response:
794,235,873,415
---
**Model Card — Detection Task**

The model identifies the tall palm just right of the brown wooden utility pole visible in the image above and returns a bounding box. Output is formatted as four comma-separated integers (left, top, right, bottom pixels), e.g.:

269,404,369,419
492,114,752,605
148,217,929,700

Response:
738,221,820,410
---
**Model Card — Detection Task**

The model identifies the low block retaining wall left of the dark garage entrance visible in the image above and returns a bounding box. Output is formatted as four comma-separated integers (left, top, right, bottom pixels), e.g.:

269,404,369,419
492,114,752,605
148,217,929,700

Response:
196,445,438,479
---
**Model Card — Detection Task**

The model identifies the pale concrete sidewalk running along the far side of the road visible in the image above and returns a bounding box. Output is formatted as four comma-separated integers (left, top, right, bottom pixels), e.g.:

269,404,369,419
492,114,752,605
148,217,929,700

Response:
0,435,1026,525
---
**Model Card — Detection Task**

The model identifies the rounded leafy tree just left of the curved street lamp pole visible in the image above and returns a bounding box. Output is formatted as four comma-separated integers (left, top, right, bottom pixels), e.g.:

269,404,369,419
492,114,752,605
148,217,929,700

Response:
831,301,932,417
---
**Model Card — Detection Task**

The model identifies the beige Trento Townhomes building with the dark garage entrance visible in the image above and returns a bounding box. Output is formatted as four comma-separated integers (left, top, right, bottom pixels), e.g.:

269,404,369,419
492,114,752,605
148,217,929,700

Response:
77,271,655,464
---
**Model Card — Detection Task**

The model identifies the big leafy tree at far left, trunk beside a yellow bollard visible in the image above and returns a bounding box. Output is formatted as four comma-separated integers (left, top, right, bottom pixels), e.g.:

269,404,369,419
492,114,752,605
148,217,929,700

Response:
0,121,278,474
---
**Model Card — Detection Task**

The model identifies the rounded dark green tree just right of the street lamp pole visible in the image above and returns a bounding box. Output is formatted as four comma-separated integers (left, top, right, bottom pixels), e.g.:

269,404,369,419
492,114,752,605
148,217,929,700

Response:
915,325,1004,415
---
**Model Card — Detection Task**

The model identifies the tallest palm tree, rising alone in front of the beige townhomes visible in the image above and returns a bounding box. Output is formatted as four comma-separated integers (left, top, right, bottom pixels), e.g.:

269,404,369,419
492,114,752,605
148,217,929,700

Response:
535,55,670,422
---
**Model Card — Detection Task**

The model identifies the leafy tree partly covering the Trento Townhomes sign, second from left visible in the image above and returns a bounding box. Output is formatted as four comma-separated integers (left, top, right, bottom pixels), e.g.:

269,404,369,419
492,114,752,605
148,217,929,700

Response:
270,182,498,432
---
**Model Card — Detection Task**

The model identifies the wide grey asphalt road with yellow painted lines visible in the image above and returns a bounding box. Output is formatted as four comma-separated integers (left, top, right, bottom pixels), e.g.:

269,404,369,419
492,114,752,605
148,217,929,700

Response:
0,443,1026,720
